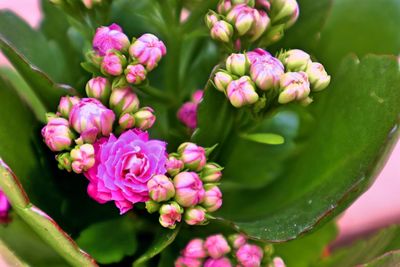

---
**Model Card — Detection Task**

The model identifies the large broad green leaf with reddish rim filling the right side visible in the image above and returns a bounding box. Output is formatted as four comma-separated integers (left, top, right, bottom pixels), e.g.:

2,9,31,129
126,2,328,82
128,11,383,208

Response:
219,55,400,241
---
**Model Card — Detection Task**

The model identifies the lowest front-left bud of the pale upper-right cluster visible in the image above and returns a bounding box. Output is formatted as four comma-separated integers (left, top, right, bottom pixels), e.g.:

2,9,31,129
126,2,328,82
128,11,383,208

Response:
226,76,259,108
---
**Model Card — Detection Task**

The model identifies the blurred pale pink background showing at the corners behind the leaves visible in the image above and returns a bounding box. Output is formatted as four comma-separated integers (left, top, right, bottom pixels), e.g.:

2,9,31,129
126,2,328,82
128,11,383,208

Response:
0,0,400,242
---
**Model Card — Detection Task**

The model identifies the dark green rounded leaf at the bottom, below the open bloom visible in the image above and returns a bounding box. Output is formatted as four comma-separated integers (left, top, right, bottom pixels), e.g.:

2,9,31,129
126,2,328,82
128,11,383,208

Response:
76,216,138,264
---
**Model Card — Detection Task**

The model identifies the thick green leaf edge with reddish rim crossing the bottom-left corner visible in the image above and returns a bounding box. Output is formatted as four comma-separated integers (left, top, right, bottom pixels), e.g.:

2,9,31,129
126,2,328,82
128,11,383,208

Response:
0,158,98,267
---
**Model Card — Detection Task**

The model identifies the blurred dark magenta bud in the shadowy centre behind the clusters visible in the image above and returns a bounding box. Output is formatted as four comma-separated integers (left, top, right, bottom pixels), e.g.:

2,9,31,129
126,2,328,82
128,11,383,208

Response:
177,90,203,130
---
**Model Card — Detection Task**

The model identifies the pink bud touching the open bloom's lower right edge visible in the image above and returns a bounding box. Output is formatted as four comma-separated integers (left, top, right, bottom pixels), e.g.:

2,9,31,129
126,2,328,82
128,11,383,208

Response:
147,174,175,202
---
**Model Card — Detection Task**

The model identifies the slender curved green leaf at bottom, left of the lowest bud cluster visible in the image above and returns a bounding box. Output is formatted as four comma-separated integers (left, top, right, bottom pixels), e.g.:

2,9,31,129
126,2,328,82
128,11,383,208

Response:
132,226,180,267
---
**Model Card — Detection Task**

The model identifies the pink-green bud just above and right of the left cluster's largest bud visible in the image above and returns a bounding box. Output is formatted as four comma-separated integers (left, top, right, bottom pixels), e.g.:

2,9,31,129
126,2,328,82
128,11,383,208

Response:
110,87,140,115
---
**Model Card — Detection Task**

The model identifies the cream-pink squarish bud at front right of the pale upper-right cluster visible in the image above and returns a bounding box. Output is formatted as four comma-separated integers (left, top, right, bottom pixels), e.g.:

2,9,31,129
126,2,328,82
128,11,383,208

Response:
278,71,310,104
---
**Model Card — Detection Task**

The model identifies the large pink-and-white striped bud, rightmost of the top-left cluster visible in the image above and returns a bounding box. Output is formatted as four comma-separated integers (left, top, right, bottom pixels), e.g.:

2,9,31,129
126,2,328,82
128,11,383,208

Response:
129,33,167,71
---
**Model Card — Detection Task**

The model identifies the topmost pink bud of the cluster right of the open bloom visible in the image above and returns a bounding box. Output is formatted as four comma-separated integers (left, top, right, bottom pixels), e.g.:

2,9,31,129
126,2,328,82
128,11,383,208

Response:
178,142,207,171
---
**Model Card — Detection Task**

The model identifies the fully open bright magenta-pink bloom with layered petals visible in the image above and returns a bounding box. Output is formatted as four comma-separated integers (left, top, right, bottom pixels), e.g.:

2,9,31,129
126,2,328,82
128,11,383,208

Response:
84,130,167,214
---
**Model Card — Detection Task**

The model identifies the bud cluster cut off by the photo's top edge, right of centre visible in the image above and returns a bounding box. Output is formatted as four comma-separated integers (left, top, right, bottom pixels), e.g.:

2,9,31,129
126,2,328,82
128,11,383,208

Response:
206,0,299,49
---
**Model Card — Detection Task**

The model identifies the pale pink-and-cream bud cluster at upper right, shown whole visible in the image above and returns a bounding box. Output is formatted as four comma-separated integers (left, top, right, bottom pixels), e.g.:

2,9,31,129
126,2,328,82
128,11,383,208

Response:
214,48,330,108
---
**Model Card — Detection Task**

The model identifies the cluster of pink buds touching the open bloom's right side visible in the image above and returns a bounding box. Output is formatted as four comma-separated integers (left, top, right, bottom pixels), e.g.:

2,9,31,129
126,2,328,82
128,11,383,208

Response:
146,143,222,229
